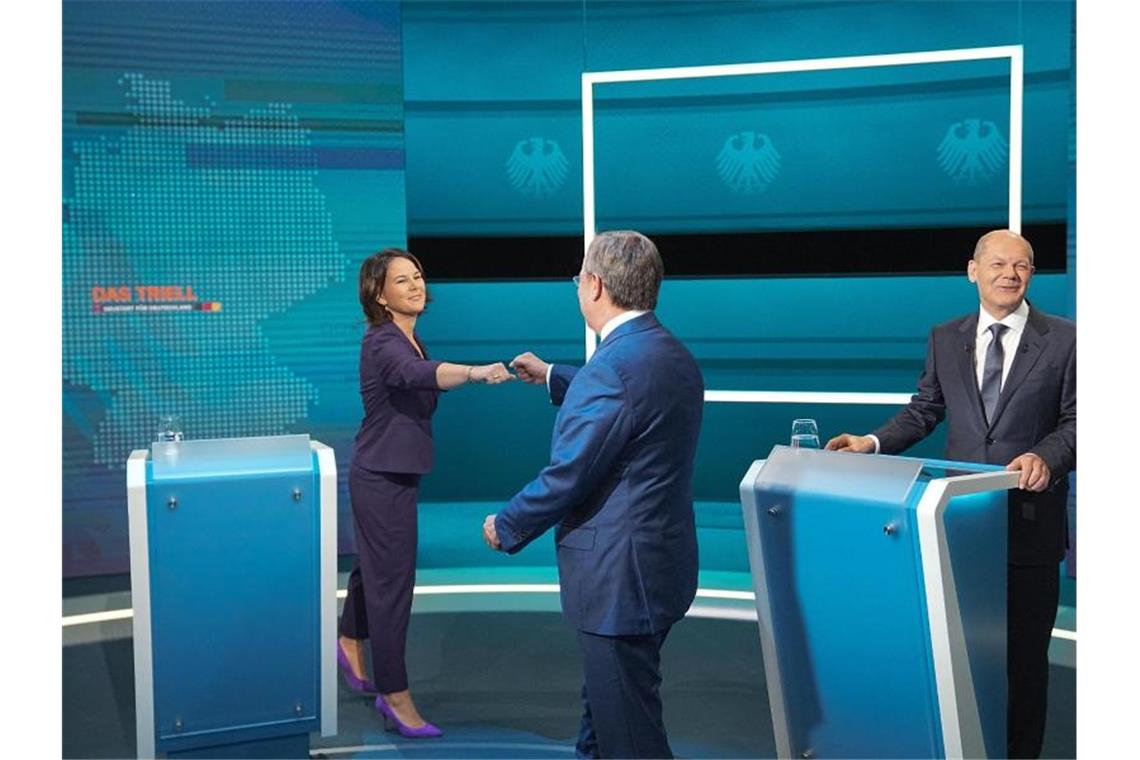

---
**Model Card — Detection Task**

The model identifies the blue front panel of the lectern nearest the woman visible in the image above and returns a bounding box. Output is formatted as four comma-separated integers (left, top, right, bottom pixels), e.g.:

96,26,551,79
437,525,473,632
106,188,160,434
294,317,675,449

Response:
147,467,319,750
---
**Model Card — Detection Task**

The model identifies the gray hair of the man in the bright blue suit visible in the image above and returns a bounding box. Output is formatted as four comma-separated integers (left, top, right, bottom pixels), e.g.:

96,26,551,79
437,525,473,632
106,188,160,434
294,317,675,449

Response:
583,230,665,311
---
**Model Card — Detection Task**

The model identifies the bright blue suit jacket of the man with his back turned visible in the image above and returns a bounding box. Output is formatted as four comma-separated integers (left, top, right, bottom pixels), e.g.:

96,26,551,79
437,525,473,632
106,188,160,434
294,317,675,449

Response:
495,313,705,636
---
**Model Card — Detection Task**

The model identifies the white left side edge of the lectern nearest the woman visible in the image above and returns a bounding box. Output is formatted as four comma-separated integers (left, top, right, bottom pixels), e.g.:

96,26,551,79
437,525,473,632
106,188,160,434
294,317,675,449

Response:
127,449,155,758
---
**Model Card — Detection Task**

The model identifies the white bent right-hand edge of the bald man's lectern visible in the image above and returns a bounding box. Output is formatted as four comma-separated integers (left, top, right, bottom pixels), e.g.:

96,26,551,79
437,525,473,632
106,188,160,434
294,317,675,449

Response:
915,472,1018,758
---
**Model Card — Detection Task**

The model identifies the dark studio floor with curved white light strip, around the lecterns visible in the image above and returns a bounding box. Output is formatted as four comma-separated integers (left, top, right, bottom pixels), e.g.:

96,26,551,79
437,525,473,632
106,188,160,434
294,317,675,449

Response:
63,573,1076,759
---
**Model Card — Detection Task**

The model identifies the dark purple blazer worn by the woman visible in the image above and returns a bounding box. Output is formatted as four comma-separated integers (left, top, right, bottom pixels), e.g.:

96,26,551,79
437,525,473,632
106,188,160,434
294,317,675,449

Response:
352,322,441,474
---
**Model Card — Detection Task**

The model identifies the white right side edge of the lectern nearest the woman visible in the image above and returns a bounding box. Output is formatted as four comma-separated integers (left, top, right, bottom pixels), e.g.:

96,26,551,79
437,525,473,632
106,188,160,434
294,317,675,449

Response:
310,441,336,736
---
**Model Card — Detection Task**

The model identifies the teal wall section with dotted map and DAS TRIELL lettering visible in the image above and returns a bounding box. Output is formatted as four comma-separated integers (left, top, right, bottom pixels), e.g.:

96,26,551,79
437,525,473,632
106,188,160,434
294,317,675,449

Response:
60,0,406,569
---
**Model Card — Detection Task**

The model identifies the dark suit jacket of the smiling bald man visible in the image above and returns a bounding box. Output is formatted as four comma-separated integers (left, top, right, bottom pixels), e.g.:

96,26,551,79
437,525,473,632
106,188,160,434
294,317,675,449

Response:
874,307,1076,565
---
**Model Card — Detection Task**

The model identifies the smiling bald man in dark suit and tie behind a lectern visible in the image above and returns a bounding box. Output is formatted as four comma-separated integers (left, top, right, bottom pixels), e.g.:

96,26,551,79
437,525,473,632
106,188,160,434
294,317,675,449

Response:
828,230,1076,758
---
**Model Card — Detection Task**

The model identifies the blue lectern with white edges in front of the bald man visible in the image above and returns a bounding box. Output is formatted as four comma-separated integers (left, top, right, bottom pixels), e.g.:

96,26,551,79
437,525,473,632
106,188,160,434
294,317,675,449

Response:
740,446,1018,758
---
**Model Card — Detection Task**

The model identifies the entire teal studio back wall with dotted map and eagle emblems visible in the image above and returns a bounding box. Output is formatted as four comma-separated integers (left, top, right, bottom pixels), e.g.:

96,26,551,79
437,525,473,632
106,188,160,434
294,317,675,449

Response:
62,0,1076,577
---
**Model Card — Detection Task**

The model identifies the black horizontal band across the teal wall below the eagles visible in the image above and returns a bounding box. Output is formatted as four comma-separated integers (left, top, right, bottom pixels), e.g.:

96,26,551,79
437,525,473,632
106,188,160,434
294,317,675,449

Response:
408,222,1068,281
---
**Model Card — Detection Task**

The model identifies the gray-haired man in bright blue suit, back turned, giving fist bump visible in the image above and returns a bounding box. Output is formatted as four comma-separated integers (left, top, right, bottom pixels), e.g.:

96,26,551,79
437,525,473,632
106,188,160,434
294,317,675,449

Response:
483,231,705,758
